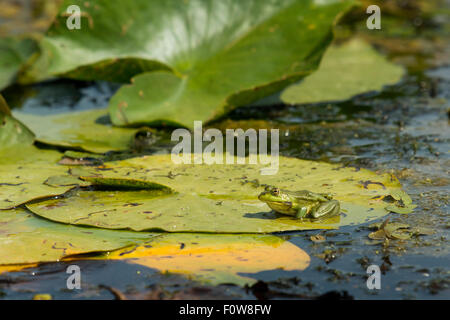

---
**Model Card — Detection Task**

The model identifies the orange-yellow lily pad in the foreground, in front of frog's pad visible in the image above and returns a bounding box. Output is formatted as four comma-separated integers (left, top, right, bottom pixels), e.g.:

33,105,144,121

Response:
82,233,310,286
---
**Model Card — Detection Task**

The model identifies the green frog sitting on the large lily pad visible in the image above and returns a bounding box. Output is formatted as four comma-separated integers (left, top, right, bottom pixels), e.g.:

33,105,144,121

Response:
258,186,340,219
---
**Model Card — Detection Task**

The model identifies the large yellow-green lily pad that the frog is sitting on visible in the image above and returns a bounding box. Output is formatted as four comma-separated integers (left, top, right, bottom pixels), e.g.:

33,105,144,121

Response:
28,155,408,233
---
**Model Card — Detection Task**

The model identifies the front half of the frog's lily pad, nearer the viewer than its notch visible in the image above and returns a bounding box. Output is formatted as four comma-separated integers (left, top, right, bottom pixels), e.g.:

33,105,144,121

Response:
27,191,340,233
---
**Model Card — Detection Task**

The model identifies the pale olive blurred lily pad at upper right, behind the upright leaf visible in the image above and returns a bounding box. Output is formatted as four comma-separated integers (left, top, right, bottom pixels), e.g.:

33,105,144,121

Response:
281,39,404,104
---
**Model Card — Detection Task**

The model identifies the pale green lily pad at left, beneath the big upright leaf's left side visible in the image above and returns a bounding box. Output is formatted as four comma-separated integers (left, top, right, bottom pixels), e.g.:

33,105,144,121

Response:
14,110,142,153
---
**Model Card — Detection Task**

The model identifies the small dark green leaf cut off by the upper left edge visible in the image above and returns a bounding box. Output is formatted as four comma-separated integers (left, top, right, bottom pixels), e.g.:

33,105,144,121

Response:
0,38,37,91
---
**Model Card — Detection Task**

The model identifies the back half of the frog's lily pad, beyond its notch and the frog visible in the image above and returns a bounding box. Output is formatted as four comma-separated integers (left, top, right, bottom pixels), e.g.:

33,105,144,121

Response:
80,154,401,202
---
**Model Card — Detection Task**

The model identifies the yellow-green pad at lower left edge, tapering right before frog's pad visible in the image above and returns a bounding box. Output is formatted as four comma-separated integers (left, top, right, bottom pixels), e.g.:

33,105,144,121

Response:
0,209,155,264
